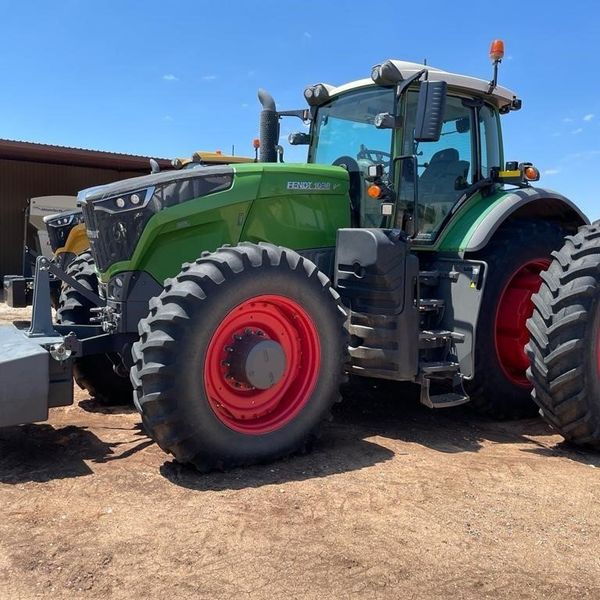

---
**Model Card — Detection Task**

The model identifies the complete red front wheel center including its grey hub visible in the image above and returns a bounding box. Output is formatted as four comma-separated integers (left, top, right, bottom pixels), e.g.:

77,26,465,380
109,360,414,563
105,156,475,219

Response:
204,294,321,435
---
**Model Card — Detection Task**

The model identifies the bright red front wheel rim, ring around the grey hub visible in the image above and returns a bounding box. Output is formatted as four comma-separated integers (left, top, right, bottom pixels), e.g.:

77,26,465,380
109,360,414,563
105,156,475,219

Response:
204,294,321,435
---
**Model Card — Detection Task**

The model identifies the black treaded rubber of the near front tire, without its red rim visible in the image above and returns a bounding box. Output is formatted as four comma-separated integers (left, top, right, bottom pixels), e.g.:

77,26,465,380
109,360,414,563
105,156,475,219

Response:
131,243,347,471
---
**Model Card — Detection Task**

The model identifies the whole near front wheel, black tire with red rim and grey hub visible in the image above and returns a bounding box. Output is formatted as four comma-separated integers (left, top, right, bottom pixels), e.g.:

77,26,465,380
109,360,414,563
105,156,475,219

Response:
131,243,347,471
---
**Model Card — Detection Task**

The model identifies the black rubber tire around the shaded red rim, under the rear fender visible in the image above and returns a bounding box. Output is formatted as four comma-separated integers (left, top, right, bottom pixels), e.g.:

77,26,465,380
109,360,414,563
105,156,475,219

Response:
465,220,564,419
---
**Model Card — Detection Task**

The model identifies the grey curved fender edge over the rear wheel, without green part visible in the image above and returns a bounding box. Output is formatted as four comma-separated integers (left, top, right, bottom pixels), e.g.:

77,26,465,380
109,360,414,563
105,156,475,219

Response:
462,188,590,254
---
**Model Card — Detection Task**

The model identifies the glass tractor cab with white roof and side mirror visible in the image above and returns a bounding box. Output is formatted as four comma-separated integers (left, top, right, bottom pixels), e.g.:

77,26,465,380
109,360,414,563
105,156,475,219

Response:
298,61,521,244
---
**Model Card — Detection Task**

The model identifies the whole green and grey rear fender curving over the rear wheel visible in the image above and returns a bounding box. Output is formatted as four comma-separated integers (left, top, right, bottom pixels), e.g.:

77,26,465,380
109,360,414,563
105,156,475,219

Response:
428,187,590,257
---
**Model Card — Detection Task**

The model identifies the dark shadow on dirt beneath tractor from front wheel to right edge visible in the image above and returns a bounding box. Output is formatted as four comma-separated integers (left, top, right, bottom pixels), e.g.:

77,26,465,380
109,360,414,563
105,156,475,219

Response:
160,385,600,491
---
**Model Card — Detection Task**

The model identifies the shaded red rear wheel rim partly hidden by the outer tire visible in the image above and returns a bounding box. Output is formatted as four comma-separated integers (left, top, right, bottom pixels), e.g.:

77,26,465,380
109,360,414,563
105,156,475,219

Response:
494,258,550,387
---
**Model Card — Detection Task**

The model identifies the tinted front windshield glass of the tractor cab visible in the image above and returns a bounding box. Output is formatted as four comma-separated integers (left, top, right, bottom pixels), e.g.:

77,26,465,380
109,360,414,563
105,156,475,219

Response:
309,88,394,170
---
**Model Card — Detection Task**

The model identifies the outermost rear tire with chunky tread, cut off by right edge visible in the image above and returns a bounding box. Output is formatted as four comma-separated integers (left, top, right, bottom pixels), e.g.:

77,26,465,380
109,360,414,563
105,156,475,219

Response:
527,222,600,448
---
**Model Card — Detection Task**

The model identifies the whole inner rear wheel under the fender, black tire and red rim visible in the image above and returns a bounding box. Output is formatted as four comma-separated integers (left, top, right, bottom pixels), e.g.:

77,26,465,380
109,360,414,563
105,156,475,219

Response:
465,220,564,419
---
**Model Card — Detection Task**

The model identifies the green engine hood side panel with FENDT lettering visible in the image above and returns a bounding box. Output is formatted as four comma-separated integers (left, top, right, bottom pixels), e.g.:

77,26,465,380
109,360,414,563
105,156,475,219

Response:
100,164,350,284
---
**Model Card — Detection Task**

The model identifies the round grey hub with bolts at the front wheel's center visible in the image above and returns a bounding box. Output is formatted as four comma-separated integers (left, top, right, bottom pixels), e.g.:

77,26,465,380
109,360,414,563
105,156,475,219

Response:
227,330,286,390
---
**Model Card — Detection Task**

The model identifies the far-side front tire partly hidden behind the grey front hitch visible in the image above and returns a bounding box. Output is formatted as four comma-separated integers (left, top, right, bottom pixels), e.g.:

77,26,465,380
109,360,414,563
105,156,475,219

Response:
56,252,133,406
